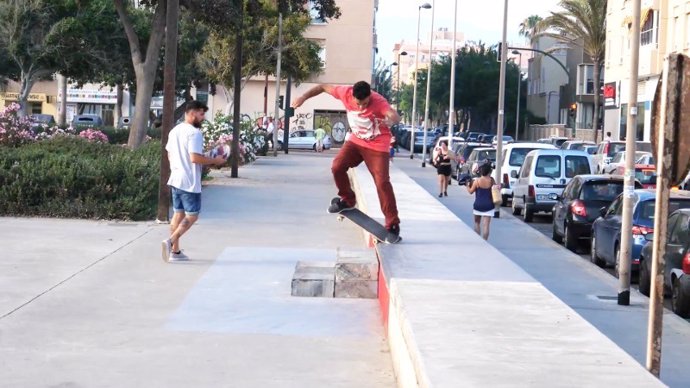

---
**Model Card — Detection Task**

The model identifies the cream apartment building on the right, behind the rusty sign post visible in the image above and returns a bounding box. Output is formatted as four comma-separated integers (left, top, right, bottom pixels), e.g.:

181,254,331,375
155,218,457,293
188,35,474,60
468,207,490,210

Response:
604,0,690,140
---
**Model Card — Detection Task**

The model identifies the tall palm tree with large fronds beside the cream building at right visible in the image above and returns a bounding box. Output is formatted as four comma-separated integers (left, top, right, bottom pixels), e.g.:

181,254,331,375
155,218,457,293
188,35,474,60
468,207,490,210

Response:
536,0,607,140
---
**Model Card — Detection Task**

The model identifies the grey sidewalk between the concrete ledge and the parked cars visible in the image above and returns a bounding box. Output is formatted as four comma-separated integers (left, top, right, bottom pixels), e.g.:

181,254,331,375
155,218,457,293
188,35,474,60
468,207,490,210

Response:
395,155,690,387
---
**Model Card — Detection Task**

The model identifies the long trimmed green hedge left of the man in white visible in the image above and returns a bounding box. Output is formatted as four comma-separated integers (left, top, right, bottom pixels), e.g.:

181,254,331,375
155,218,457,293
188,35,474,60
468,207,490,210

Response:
0,137,160,220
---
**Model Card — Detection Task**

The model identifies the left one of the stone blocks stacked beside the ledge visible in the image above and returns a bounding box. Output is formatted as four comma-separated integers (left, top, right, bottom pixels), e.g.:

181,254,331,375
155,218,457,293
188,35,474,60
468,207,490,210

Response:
292,261,335,298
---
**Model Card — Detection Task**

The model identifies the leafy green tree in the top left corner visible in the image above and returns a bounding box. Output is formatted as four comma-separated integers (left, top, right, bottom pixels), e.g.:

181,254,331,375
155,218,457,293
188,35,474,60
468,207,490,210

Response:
0,0,93,115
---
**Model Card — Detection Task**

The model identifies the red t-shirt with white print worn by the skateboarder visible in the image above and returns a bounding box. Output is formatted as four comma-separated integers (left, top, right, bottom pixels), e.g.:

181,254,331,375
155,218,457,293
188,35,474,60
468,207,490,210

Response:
331,86,391,153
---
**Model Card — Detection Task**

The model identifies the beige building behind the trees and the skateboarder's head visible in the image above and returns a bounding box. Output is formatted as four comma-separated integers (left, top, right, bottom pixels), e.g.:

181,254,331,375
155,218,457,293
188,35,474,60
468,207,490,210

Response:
204,0,378,145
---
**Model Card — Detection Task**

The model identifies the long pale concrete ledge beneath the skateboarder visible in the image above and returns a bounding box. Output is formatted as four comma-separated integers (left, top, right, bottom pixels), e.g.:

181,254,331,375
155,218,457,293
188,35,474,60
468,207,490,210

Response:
353,165,663,387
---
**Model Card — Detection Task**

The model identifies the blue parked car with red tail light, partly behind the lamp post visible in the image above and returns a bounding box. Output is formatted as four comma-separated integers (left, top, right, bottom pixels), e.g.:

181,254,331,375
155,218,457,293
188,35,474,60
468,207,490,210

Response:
590,189,690,273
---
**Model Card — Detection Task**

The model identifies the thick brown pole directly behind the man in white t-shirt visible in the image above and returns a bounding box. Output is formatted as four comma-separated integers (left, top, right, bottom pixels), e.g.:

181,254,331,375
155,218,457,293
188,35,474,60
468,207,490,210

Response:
156,0,180,223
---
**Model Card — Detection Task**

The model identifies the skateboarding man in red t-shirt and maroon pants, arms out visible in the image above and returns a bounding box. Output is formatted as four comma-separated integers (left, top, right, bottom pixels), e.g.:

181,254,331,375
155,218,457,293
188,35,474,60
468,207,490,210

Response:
292,81,400,242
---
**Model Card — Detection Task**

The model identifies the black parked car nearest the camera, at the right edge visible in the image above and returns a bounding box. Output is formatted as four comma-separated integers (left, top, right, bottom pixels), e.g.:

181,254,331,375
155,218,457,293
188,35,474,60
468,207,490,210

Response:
639,209,690,318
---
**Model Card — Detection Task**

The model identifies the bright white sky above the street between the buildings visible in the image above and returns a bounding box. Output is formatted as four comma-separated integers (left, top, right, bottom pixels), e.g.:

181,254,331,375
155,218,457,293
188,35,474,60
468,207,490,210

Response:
376,0,559,63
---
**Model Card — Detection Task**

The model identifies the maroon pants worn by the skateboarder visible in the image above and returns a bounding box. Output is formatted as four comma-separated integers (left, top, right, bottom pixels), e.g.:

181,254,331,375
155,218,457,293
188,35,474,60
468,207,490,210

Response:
331,141,400,228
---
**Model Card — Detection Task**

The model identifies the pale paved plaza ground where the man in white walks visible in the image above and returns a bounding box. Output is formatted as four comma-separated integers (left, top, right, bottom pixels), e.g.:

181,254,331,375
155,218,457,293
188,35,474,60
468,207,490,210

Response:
0,153,395,388
